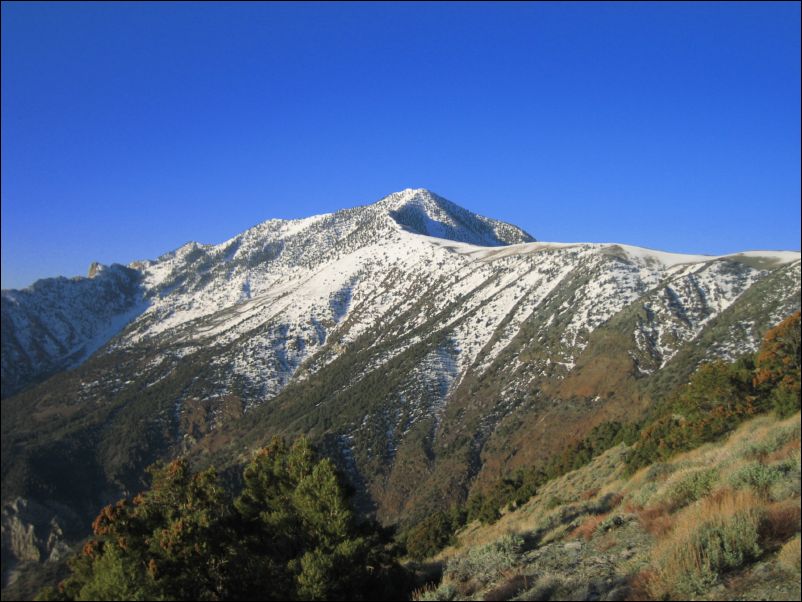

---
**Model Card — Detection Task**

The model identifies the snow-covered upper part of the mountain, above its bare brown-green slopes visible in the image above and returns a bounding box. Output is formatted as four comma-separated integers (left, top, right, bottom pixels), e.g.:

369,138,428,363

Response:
3,189,799,424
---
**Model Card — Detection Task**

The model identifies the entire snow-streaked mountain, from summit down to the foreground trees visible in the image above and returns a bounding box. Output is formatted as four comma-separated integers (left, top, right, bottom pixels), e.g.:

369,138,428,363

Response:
2,189,800,544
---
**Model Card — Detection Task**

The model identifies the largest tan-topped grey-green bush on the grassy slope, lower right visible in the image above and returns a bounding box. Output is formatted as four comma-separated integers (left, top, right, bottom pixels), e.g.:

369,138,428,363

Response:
650,490,764,599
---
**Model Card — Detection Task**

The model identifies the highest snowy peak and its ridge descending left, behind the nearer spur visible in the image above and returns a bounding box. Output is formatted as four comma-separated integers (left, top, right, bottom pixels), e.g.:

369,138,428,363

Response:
2,189,534,397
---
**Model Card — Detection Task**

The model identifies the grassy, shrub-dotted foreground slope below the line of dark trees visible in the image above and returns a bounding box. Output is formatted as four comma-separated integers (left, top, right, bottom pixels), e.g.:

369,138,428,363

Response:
417,413,801,600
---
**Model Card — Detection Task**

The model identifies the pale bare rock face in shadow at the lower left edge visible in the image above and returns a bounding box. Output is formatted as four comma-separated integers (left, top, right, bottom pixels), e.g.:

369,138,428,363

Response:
0,498,71,587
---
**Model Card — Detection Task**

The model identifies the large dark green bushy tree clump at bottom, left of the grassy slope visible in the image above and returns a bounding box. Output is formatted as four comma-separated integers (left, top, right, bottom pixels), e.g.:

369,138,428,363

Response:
42,439,405,600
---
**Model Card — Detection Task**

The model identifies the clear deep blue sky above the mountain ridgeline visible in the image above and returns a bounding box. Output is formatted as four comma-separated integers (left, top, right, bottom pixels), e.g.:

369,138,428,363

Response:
2,2,800,288
